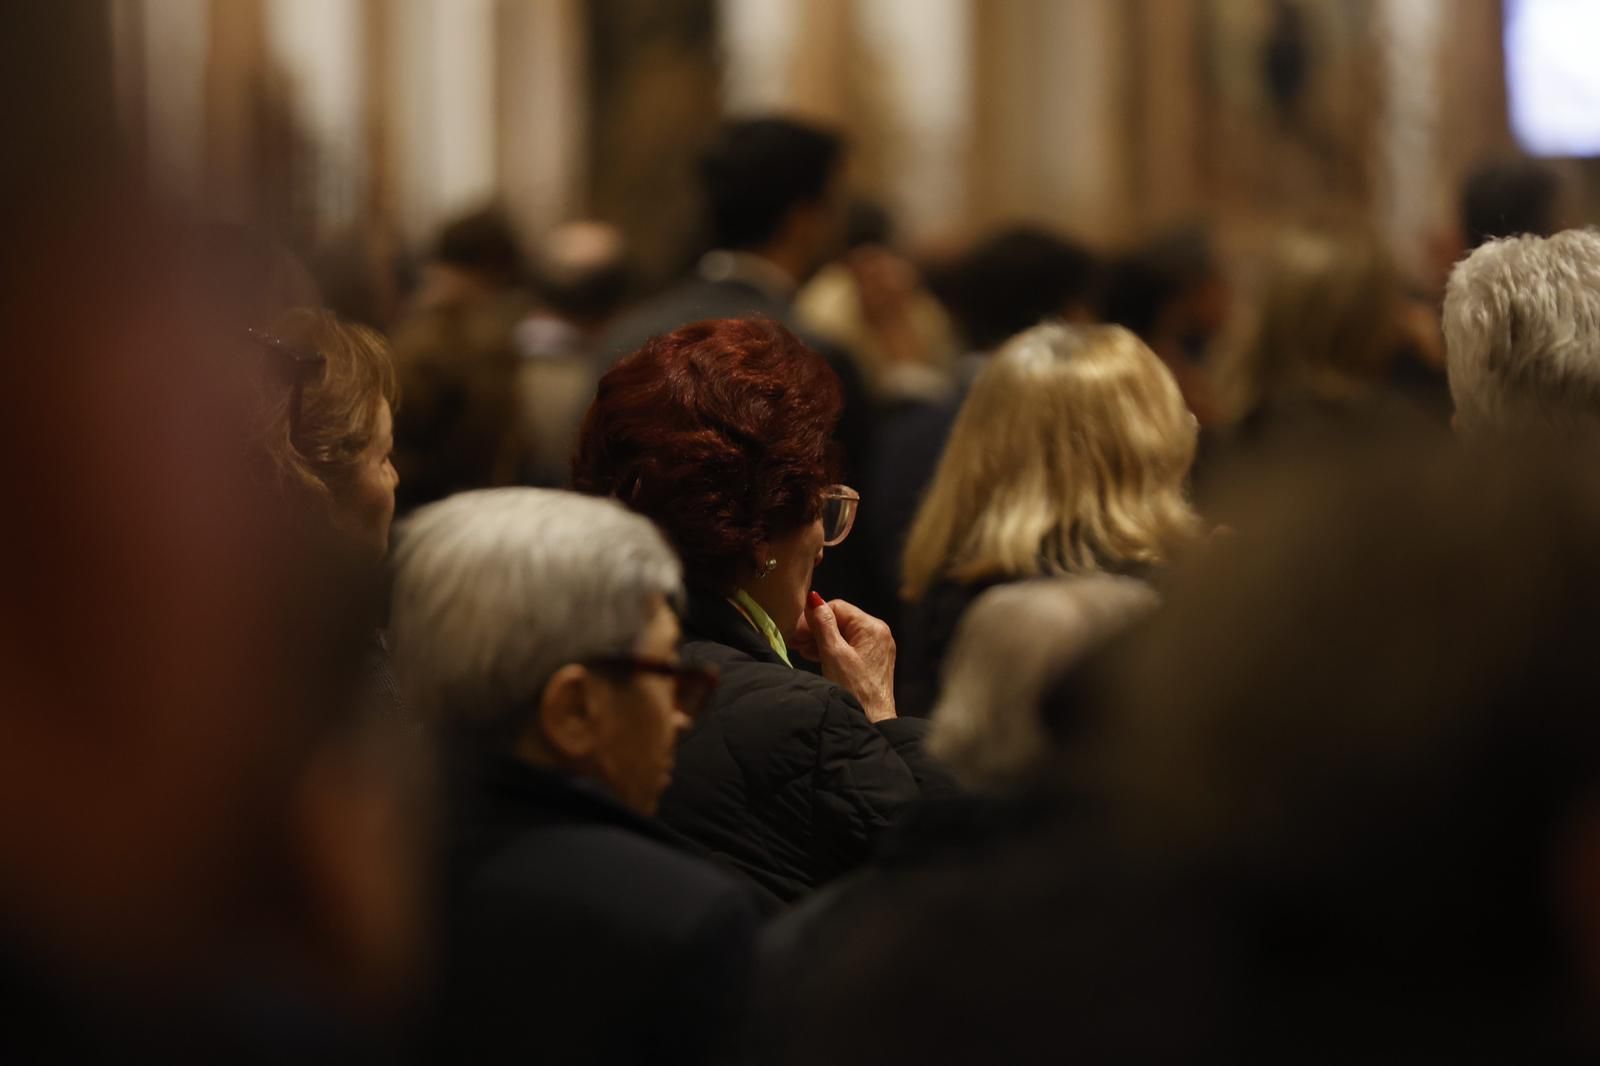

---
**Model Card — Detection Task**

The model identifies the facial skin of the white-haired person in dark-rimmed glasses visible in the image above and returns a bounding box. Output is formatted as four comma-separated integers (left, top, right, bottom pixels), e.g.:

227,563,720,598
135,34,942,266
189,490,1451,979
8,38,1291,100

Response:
590,597,690,815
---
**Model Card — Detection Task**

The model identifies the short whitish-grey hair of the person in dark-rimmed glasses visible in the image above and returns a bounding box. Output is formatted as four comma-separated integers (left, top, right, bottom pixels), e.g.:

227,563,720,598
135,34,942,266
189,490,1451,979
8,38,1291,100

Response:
389,488,683,744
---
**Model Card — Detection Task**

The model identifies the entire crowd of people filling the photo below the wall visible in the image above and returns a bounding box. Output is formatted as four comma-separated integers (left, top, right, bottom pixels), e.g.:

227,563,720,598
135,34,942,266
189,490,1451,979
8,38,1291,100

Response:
9,33,1600,1066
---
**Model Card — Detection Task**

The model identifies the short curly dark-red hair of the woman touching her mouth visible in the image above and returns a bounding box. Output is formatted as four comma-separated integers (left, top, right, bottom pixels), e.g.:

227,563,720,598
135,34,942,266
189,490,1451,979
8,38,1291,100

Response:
573,319,843,592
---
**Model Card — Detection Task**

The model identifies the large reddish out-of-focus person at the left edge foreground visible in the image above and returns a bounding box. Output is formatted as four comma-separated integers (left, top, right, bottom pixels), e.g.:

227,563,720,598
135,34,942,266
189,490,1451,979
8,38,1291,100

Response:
0,18,422,1061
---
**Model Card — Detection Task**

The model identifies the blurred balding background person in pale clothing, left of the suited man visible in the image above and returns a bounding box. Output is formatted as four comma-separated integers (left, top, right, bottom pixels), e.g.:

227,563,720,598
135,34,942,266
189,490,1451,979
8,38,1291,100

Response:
517,221,629,488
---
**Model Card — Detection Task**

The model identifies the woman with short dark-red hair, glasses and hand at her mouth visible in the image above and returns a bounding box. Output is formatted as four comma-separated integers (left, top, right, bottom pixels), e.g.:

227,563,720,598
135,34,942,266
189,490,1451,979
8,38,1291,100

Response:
573,319,944,900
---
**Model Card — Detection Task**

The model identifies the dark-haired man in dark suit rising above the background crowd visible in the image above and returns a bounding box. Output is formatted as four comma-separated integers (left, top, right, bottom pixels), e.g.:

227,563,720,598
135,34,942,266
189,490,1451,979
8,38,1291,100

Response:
598,118,893,615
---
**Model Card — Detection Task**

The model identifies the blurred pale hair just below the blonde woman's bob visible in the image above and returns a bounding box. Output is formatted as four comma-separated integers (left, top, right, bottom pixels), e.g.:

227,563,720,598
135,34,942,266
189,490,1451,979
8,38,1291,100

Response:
928,575,1157,789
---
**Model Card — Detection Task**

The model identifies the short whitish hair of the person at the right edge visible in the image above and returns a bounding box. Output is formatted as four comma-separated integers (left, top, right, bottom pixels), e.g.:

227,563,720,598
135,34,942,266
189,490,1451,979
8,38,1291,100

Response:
1443,229,1600,434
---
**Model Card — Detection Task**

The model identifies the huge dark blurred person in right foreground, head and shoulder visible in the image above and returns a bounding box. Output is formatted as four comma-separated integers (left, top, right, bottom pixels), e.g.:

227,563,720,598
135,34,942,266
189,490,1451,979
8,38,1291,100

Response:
784,428,1600,1066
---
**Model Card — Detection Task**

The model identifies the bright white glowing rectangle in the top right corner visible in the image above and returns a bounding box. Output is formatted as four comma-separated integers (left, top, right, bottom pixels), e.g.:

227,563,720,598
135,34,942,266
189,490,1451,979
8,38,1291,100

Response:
1506,0,1600,157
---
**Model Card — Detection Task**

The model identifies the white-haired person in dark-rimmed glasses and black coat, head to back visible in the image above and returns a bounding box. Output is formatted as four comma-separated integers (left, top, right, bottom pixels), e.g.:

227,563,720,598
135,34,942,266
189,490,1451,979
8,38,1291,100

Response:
394,488,760,1064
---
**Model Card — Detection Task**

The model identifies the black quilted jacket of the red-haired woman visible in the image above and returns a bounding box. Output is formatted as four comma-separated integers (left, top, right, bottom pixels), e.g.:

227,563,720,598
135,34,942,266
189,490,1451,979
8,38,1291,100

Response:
661,597,955,901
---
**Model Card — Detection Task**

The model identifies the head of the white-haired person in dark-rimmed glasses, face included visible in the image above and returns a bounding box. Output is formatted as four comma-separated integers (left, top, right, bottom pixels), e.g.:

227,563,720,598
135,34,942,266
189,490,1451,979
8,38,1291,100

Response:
390,488,706,813
